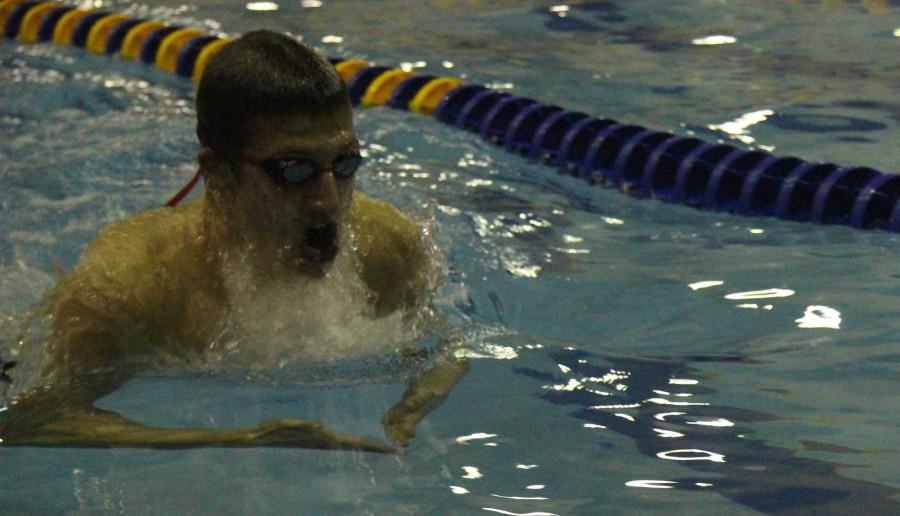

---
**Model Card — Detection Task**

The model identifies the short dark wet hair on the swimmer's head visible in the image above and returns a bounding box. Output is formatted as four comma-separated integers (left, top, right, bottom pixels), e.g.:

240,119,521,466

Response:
197,30,350,155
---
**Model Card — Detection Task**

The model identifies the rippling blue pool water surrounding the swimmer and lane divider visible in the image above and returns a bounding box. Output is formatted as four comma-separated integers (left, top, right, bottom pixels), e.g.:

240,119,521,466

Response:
0,0,900,515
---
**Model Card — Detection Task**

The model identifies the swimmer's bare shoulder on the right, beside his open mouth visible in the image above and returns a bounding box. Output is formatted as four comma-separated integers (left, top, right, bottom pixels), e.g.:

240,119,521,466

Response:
348,193,435,315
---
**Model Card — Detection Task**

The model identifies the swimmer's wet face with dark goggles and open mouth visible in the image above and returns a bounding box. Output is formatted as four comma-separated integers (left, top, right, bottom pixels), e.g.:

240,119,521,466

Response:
214,106,359,274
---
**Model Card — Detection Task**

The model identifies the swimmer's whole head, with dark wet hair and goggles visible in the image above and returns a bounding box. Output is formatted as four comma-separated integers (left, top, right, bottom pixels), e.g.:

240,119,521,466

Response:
197,31,359,274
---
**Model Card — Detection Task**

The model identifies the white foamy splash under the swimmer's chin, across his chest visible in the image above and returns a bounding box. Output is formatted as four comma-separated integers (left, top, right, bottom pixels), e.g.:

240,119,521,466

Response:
208,249,418,368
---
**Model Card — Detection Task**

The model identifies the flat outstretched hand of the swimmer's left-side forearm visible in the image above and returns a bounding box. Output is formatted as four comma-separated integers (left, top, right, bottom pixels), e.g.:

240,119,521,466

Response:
247,418,397,453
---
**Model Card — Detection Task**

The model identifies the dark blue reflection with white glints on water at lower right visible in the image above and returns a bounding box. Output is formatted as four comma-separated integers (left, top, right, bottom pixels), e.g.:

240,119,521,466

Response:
518,348,900,514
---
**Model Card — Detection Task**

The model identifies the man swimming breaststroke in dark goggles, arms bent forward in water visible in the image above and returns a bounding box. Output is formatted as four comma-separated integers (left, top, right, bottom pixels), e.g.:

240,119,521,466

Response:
0,31,466,452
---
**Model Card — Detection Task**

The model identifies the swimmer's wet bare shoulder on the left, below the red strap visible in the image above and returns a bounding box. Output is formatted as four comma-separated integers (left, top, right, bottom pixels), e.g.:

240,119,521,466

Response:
47,202,209,373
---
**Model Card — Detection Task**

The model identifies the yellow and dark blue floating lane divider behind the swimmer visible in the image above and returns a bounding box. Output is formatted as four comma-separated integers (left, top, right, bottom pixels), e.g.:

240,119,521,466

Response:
0,0,900,232
